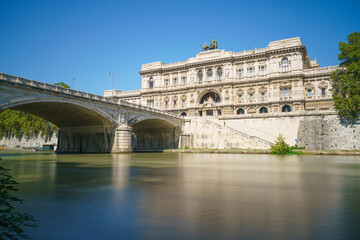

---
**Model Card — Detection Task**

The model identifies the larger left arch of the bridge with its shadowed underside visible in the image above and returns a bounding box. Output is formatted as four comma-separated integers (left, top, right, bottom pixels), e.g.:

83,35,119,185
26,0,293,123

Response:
0,96,117,153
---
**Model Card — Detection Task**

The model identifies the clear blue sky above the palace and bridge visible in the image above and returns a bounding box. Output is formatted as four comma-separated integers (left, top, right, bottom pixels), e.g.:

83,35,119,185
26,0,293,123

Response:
0,0,360,95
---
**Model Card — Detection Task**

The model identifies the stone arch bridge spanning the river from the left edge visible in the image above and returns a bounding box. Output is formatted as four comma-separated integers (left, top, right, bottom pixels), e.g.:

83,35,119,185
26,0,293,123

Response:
0,73,190,153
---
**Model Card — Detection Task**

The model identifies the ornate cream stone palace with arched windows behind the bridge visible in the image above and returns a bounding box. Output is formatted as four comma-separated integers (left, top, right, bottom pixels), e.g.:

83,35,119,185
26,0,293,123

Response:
105,38,336,118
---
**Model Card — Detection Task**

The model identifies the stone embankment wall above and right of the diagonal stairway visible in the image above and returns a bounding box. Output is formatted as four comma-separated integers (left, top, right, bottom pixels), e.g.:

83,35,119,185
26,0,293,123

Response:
210,114,360,150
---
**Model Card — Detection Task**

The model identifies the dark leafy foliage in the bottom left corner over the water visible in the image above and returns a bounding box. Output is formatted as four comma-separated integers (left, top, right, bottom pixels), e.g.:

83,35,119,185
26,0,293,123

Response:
0,160,36,240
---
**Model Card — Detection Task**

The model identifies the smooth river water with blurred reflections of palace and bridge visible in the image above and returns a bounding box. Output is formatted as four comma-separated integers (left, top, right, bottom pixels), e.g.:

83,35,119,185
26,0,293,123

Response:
0,152,360,240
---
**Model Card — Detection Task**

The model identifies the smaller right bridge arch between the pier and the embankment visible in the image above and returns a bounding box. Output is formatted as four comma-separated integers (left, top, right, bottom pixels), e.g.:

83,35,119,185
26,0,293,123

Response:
129,116,181,151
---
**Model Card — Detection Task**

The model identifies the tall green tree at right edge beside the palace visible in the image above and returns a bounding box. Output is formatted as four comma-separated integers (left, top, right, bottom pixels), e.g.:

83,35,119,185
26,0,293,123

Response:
330,32,360,121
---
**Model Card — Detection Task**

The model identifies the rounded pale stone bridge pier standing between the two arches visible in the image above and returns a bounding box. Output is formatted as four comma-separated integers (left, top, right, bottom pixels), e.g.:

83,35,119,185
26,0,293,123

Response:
111,125,133,153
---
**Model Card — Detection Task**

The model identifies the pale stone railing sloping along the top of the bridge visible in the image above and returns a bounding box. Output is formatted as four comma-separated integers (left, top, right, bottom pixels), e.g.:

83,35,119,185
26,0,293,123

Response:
0,73,184,118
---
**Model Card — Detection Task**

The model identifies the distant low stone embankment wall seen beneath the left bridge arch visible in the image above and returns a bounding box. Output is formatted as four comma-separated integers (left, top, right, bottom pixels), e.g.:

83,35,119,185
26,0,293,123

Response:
0,133,57,148
